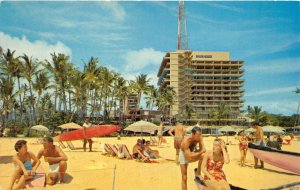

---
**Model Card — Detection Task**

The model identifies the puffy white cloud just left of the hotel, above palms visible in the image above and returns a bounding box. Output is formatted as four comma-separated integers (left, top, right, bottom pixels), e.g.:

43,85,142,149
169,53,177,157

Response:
122,48,164,72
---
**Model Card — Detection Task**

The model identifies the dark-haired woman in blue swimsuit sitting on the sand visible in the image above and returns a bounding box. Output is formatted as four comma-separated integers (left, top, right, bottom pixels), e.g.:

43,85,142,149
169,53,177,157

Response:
8,140,41,189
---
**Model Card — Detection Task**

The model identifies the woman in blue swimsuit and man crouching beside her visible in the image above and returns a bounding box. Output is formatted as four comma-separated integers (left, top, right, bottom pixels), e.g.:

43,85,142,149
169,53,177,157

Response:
8,137,68,189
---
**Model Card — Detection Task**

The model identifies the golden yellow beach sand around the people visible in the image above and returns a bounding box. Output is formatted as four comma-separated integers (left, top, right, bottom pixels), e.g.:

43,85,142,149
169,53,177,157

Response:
0,137,300,190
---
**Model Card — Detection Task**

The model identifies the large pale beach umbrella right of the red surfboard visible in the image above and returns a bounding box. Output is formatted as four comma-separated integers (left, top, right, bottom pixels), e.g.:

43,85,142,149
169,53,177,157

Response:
124,120,158,134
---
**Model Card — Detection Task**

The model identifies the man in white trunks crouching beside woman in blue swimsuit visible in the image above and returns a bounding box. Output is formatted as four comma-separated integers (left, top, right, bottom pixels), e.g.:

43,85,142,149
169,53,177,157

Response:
37,137,68,185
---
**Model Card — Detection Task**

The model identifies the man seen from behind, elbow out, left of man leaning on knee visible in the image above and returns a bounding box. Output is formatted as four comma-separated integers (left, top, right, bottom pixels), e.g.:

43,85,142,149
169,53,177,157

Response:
168,121,185,164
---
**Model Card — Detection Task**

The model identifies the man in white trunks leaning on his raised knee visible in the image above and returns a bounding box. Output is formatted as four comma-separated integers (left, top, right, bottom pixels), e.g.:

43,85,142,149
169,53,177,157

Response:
179,127,206,190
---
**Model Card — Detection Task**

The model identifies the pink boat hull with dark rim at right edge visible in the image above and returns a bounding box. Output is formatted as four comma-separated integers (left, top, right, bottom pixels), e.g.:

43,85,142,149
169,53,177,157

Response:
248,143,300,174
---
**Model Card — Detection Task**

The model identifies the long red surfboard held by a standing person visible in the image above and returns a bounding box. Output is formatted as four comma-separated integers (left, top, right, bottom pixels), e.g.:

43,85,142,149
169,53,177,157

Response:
54,125,121,141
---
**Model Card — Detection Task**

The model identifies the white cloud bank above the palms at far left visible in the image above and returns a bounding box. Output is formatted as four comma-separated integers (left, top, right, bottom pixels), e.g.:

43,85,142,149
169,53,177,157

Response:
0,32,72,60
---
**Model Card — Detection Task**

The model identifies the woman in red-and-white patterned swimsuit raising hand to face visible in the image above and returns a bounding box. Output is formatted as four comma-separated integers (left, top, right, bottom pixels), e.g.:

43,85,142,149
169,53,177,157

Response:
201,138,230,190
